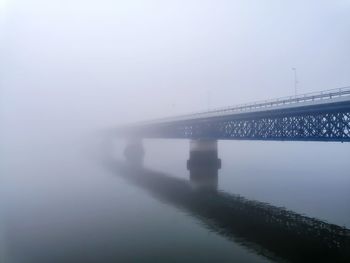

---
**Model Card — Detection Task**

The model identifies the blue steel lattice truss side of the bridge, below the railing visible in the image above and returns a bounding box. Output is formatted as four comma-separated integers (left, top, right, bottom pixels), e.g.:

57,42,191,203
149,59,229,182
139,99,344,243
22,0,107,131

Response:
123,102,350,142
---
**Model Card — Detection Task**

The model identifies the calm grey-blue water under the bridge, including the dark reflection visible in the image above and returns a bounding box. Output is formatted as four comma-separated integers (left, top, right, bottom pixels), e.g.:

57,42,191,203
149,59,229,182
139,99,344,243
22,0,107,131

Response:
0,136,350,263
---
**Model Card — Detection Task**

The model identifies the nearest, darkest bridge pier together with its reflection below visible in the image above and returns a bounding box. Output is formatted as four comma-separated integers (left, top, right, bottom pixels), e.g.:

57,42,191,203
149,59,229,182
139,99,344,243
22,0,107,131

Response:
187,139,221,191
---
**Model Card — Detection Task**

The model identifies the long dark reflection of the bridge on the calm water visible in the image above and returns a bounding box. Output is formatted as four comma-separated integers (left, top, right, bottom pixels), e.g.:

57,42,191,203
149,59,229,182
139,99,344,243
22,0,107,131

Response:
104,144,350,262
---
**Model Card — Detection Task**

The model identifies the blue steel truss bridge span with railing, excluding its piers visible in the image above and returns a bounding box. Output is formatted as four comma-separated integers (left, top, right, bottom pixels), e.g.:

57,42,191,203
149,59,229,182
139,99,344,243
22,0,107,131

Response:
118,87,350,142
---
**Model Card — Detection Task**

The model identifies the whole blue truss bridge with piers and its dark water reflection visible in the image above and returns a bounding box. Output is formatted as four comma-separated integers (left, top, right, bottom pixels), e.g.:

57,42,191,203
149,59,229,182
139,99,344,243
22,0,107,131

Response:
105,87,350,262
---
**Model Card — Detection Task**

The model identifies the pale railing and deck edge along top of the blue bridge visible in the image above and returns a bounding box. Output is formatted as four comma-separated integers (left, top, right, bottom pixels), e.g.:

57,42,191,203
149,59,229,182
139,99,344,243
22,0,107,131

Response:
144,86,350,124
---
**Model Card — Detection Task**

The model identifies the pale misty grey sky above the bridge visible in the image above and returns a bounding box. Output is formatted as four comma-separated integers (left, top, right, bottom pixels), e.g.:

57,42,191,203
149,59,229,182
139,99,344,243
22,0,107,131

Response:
0,0,350,127
